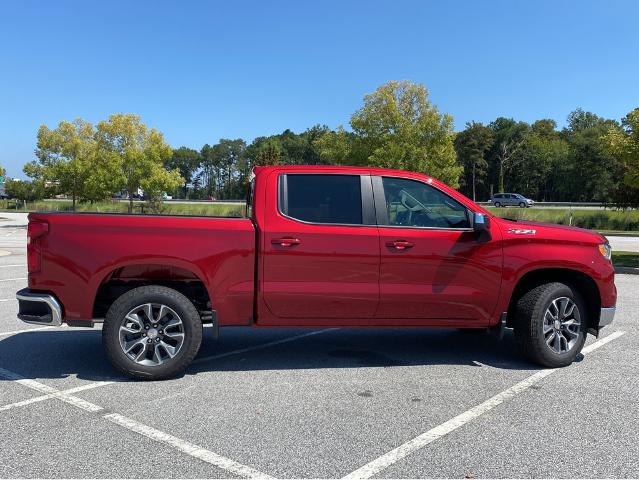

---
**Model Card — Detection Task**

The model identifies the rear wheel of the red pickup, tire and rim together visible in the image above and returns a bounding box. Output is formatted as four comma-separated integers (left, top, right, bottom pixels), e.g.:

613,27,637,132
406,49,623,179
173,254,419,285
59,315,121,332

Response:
102,285,202,380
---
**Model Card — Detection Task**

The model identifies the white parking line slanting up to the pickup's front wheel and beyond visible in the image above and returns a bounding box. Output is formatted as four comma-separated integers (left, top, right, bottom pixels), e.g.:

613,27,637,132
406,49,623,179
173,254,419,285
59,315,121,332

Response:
344,331,626,480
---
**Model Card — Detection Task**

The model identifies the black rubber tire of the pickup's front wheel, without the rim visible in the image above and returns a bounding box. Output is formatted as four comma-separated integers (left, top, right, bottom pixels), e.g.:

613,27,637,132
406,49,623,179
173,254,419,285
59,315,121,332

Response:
514,282,588,368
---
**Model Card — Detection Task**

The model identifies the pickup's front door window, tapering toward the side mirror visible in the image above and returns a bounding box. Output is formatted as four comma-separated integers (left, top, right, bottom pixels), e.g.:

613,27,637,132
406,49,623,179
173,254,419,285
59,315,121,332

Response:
382,177,470,228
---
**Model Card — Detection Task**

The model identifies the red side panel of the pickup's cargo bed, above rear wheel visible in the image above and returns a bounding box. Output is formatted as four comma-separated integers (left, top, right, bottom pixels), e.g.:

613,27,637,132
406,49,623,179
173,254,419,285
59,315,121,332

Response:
29,213,255,324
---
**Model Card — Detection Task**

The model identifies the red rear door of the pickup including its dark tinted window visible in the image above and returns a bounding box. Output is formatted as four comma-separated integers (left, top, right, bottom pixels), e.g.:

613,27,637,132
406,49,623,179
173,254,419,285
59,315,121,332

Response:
259,171,380,325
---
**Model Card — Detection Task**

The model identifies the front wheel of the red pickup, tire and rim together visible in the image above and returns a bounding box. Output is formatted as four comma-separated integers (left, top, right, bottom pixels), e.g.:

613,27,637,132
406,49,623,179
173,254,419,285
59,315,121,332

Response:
514,282,588,368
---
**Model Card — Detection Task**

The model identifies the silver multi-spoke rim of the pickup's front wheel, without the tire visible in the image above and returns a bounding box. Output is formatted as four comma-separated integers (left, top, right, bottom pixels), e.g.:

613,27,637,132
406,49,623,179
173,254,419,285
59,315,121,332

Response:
543,297,581,353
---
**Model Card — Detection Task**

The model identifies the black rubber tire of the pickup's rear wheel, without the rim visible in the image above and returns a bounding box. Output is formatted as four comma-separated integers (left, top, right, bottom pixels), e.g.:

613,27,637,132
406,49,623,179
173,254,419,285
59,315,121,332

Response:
102,285,202,380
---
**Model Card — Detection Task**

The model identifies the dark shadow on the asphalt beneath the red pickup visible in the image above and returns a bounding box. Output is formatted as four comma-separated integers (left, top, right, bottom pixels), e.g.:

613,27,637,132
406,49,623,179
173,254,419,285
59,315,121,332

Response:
0,327,564,381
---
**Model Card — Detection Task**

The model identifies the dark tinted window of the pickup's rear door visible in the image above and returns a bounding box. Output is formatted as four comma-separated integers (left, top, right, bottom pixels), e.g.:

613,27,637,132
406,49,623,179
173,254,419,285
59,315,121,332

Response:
280,174,362,225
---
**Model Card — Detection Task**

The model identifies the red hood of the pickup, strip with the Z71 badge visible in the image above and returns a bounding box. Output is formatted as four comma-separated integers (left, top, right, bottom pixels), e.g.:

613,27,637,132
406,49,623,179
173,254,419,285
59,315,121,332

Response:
497,218,608,245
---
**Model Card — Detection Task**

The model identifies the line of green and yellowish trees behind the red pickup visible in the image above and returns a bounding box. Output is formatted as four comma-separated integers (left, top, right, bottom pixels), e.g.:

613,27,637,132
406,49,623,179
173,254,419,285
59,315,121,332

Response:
1,81,639,206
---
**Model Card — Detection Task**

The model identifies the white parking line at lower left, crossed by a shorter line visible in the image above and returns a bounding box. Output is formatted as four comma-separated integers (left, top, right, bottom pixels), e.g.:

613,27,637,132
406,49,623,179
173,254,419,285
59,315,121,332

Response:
0,368,273,479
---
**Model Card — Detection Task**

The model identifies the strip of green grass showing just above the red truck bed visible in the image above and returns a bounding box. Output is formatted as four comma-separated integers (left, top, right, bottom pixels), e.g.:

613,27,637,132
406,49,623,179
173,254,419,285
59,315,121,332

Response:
0,200,244,217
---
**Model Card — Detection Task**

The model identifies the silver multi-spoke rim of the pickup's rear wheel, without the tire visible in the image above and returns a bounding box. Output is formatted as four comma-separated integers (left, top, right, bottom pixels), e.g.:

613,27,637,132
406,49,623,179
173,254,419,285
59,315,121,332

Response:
120,303,184,366
